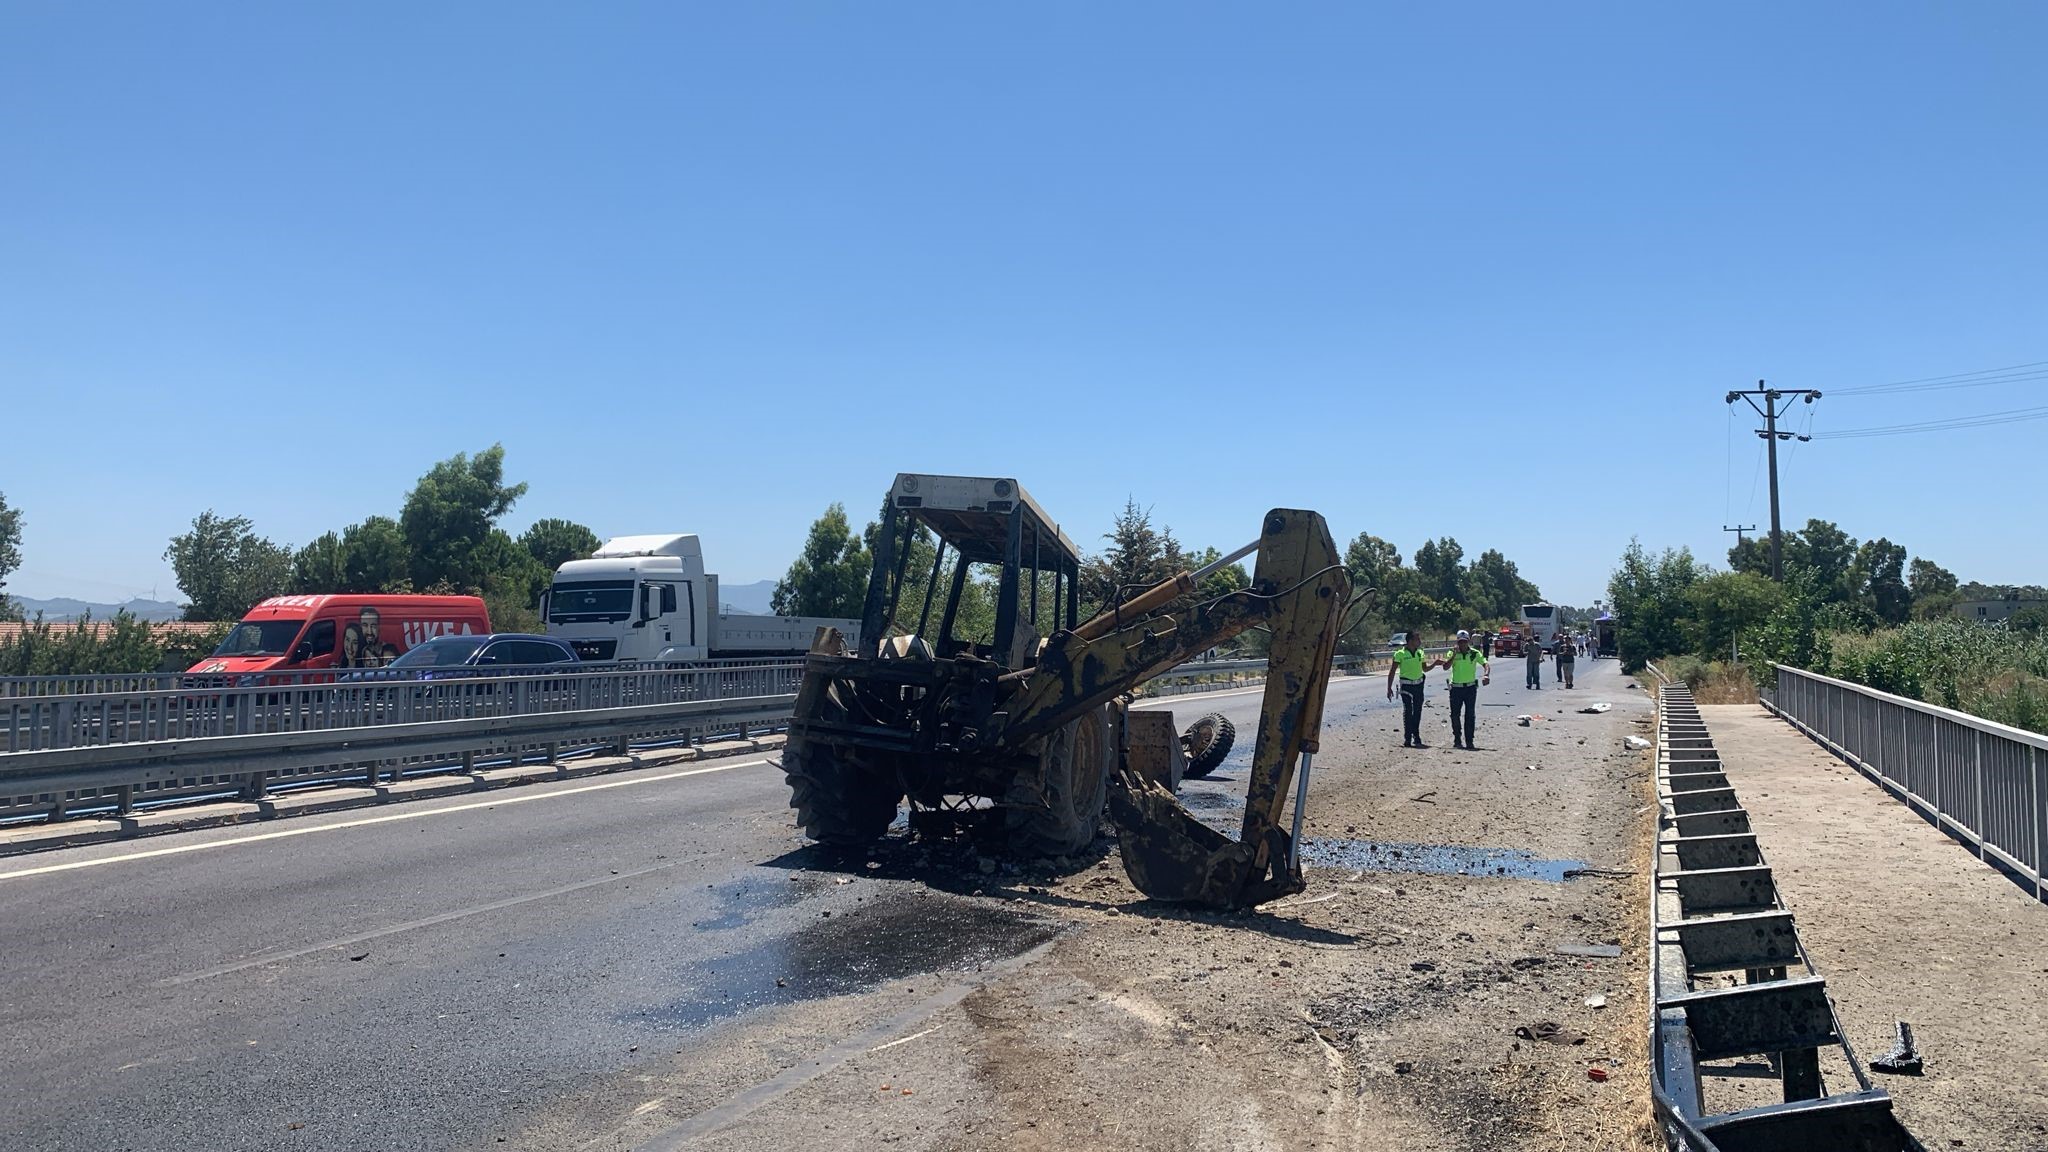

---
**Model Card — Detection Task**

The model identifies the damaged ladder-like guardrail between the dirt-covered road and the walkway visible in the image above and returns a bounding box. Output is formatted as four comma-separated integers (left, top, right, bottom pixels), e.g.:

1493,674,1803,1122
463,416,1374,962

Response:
1651,685,1921,1152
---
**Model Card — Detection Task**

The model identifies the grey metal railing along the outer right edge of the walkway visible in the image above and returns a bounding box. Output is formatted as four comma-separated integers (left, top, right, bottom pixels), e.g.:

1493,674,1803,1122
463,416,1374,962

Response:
1763,664,2048,900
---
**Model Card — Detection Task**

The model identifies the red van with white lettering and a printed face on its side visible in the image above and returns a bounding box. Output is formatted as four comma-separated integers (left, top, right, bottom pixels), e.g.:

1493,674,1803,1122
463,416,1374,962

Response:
186,594,492,676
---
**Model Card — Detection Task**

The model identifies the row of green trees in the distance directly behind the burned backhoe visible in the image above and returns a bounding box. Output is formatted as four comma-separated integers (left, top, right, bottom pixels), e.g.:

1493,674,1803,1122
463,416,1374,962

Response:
772,500,1540,652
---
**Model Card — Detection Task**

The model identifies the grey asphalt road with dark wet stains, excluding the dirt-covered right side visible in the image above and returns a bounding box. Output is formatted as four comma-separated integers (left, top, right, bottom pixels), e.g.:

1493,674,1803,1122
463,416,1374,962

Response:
0,651,1605,1152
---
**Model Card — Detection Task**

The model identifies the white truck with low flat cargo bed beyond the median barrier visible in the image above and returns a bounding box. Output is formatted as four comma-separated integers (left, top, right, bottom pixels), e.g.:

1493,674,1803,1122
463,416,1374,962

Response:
541,533,860,664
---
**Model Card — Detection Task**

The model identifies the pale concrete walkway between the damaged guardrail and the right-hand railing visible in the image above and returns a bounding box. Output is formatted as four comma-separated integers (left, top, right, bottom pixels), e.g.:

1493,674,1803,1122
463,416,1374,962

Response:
1700,705,2048,1148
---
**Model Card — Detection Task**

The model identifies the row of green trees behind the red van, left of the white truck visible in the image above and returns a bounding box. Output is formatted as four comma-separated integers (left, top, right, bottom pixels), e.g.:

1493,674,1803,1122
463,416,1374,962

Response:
164,445,598,631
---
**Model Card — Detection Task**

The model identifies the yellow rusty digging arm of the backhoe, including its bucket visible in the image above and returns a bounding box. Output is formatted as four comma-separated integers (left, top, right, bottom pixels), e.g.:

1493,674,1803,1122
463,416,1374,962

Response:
989,508,1350,908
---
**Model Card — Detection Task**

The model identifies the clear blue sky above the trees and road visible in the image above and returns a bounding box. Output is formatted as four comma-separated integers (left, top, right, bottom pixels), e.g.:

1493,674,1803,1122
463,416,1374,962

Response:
0,0,2048,605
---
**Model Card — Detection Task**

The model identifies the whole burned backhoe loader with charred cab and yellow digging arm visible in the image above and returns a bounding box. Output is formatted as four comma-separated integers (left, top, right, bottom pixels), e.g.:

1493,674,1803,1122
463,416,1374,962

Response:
782,474,1348,908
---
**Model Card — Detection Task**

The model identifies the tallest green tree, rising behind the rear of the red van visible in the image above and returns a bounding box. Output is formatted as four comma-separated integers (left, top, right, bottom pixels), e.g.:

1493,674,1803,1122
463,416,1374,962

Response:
397,445,526,588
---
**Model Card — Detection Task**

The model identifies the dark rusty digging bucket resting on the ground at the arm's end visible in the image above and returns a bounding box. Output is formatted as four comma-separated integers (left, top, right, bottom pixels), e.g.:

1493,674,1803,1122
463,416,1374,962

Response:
1110,771,1305,908
